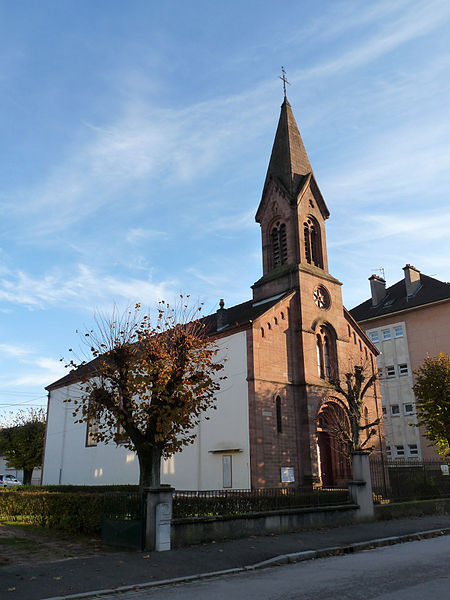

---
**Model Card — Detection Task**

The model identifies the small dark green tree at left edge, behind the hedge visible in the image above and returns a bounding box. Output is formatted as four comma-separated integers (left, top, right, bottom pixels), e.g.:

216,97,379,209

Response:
0,408,45,485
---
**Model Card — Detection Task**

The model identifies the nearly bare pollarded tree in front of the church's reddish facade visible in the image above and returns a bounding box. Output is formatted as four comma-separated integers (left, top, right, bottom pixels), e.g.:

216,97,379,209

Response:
330,365,381,454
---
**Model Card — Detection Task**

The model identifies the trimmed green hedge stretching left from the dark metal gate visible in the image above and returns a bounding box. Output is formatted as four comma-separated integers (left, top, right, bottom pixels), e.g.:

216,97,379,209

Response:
0,490,103,534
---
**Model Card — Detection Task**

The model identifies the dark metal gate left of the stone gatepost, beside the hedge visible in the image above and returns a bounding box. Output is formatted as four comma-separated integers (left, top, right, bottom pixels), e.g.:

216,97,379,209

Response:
102,492,145,550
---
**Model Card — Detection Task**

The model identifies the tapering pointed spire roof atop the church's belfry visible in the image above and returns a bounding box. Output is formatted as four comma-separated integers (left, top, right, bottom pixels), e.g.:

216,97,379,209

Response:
264,98,312,197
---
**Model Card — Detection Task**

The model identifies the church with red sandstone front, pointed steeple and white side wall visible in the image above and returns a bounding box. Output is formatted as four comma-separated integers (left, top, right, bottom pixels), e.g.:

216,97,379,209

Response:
42,96,382,490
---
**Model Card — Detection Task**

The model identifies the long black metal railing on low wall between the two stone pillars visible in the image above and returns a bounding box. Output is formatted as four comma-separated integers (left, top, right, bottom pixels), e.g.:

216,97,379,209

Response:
173,488,350,518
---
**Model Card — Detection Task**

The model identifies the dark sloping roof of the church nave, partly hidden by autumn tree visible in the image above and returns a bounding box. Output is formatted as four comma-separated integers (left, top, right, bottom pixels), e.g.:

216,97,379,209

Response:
45,292,290,391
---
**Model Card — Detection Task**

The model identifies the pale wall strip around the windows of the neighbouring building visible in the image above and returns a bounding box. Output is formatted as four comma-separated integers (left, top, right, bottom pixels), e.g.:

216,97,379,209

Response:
366,321,421,458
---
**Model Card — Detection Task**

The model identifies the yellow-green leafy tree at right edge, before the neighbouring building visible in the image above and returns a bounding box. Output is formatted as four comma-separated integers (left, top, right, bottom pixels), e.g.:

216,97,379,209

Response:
413,352,450,454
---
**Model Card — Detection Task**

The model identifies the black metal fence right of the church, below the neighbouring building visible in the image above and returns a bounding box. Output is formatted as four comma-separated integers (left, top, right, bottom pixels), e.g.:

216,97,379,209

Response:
370,458,450,503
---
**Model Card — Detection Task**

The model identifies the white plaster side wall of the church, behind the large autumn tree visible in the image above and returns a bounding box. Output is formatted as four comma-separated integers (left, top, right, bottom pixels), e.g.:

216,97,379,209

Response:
43,332,250,490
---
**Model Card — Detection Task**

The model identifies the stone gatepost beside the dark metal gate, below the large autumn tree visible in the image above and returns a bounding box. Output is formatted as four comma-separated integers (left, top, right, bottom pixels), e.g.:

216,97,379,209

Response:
145,485,175,552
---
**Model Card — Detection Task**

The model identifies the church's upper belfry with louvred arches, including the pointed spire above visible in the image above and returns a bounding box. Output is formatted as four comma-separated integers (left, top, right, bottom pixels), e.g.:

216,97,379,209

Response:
253,97,330,300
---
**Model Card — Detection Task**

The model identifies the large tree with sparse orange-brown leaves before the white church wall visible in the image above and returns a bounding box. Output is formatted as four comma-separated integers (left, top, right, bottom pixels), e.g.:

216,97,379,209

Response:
68,296,223,488
